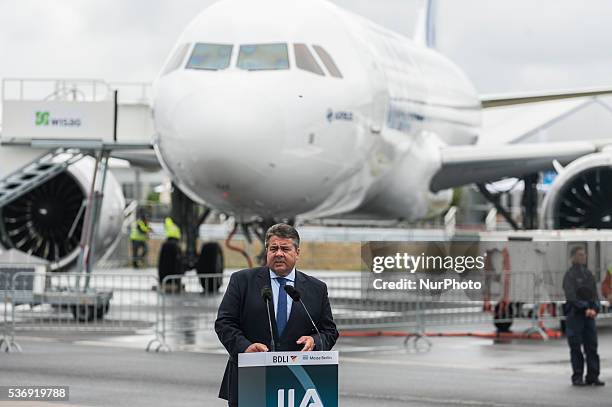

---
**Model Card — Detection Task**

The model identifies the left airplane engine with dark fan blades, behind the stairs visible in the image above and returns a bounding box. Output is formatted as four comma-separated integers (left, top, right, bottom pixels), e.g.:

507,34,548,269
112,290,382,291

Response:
0,157,125,271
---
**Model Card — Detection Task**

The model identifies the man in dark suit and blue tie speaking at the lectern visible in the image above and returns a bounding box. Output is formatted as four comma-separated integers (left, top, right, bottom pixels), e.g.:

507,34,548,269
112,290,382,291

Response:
215,223,338,406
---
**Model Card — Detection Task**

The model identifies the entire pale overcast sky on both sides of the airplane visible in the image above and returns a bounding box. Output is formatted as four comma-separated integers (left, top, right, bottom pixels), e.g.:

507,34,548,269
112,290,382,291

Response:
0,0,612,93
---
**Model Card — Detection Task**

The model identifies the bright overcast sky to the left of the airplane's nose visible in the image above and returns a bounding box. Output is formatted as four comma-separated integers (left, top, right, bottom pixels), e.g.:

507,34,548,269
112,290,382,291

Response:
0,0,212,81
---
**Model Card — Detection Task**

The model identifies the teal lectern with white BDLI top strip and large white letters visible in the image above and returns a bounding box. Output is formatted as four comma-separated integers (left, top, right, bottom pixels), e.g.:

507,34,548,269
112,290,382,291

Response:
238,351,338,407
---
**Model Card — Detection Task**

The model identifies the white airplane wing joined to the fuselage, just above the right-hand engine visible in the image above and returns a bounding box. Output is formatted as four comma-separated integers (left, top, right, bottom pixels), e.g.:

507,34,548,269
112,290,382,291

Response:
430,142,599,192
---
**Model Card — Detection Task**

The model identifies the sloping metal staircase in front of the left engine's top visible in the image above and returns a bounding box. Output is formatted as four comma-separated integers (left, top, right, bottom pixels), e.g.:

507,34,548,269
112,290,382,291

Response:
0,148,85,209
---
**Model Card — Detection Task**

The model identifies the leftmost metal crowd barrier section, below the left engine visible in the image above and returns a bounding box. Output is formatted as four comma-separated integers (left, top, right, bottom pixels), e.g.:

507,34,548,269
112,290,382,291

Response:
5,272,159,346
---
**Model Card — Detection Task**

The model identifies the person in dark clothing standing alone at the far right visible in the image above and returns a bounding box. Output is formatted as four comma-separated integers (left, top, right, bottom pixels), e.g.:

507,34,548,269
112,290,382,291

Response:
563,246,604,386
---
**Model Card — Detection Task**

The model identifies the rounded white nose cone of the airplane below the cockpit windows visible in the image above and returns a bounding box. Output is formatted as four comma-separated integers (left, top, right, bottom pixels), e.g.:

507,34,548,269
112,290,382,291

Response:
159,78,294,215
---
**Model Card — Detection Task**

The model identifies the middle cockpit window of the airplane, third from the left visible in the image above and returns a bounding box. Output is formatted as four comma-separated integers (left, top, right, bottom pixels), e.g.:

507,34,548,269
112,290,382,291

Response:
238,44,289,71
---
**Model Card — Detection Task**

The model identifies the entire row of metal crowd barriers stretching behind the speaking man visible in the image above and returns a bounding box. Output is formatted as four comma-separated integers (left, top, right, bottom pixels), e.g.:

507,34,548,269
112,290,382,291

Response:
0,270,612,352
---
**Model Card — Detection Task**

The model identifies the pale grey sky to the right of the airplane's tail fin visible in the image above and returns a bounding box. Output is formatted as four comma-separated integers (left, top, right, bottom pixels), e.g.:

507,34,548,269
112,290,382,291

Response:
438,0,612,93
